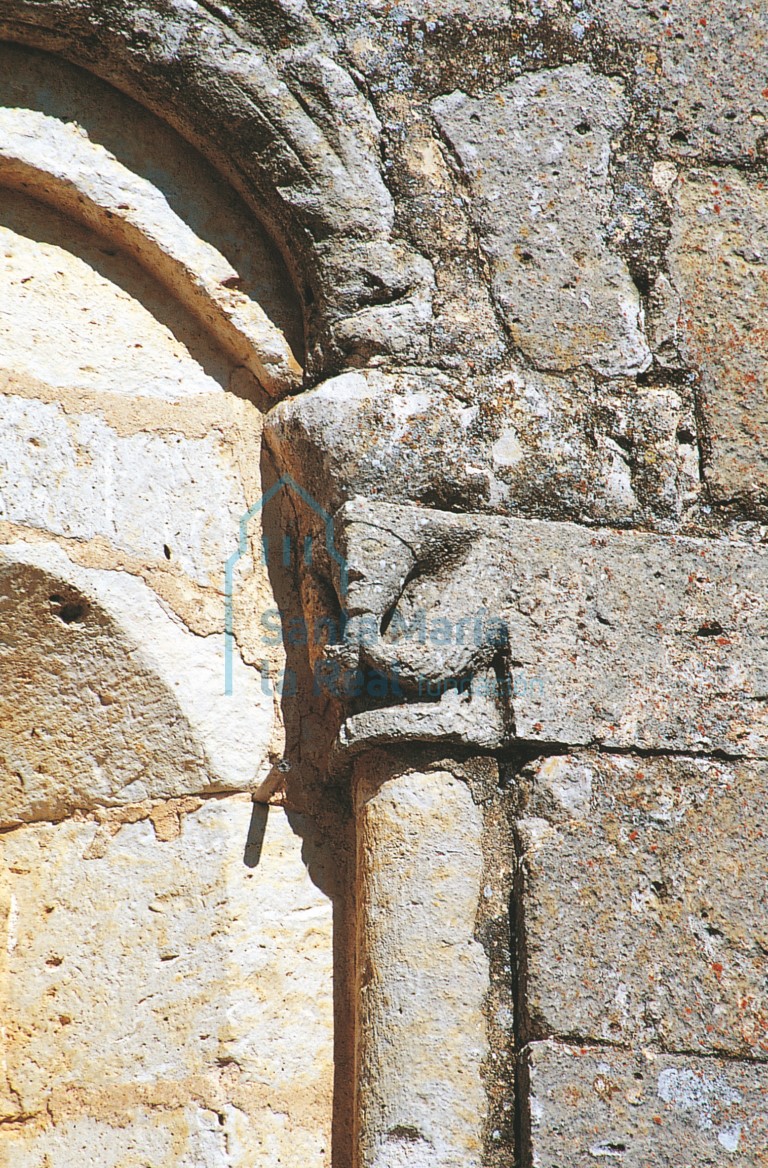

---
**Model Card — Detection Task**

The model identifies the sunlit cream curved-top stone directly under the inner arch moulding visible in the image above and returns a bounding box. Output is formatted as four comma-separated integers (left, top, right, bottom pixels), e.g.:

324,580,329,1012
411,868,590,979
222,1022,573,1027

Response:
0,189,232,401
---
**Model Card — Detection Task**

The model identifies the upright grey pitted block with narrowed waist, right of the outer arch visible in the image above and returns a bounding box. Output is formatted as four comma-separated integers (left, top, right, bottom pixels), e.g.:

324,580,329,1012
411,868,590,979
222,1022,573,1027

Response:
433,65,650,376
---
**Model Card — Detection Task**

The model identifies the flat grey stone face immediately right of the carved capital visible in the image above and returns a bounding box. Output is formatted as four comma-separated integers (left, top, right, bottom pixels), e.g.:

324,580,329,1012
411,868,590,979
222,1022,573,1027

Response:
490,524,768,758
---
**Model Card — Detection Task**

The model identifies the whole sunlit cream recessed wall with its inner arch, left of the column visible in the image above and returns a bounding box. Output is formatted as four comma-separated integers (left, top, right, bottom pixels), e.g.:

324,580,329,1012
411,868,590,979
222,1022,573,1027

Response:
0,41,333,1168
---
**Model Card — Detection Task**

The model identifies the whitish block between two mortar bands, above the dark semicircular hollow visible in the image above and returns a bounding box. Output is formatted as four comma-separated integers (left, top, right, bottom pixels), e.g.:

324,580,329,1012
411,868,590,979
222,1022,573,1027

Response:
0,395,249,586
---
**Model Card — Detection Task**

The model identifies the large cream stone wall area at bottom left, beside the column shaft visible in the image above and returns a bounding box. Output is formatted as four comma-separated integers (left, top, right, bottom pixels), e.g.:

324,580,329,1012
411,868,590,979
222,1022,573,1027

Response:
0,795,333,1168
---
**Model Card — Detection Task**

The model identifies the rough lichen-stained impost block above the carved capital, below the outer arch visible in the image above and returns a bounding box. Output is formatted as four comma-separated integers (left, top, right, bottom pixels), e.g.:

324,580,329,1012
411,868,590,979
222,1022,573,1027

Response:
265,368,699,528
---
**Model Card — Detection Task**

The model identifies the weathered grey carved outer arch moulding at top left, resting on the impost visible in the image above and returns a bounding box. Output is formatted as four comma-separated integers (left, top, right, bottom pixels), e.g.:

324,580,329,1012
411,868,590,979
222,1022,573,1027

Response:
0,0,432,378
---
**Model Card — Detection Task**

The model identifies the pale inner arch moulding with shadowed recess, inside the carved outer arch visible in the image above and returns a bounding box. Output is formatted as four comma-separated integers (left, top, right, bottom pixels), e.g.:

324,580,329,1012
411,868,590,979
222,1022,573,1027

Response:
0,41,302,397
